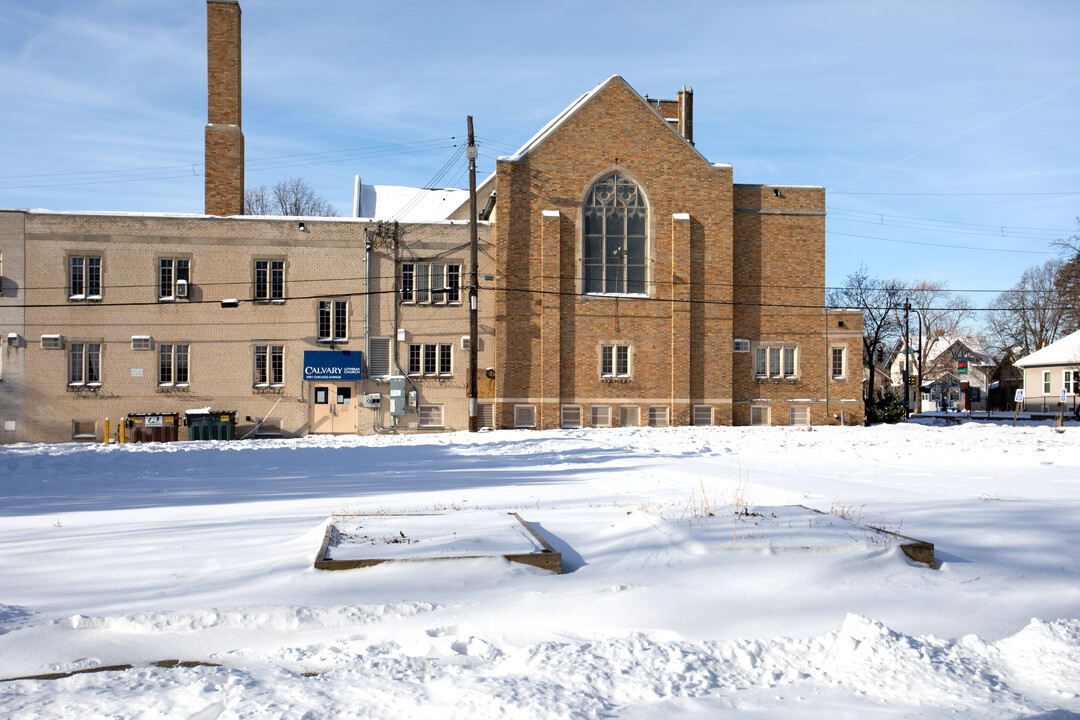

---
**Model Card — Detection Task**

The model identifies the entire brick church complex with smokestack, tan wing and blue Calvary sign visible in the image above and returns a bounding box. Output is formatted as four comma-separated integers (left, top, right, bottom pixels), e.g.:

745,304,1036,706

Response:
0,0,863,441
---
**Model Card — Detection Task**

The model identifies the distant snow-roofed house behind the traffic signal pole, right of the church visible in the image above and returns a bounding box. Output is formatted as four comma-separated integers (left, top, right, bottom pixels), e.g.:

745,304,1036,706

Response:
889,336,997,412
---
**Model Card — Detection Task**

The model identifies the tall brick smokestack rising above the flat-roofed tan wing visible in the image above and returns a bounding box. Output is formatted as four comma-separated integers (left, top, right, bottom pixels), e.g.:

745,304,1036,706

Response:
204,0,244,215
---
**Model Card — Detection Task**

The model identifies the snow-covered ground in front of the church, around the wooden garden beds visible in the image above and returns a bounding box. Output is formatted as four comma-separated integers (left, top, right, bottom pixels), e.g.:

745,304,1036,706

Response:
0,422,1080,720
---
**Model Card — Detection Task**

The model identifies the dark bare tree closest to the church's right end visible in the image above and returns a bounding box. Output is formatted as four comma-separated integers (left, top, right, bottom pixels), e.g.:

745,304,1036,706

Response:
828,264,904,400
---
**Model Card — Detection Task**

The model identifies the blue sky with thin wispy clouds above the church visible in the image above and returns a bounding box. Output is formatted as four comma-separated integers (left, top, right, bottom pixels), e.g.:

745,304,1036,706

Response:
0,0,1080,297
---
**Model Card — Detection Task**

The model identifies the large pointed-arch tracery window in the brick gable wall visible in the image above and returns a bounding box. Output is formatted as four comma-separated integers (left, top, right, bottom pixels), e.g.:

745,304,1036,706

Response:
582,172,649,295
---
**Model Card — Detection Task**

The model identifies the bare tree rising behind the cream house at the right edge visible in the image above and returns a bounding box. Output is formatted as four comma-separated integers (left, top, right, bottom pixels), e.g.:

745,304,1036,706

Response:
986,259,1068,357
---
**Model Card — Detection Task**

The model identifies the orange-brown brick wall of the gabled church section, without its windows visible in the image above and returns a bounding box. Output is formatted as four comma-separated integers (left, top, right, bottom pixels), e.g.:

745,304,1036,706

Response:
496,77,862,427
